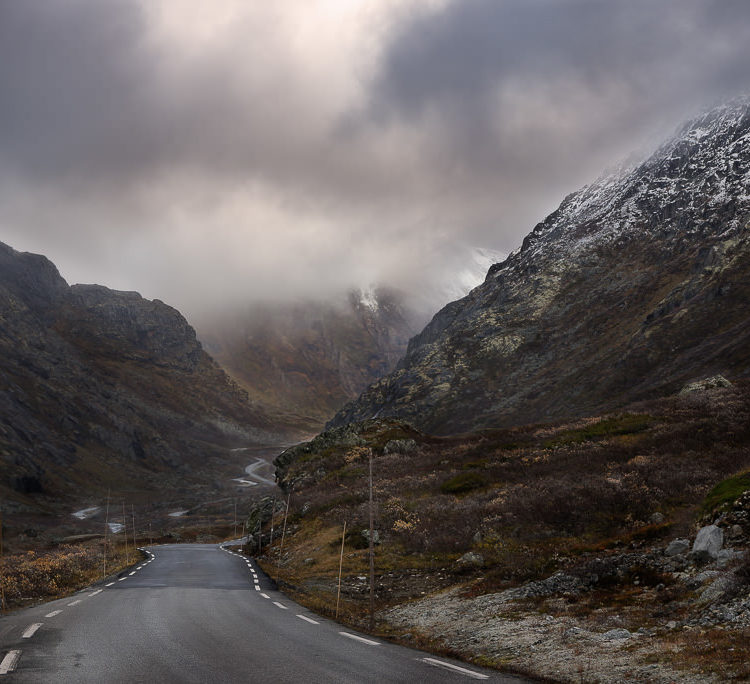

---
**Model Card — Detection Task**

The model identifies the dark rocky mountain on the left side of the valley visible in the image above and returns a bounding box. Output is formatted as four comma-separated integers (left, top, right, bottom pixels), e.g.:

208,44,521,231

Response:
0,243,285,512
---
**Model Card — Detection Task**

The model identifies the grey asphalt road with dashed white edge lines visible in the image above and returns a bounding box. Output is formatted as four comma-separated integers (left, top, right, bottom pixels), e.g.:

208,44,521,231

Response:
0,544,521,684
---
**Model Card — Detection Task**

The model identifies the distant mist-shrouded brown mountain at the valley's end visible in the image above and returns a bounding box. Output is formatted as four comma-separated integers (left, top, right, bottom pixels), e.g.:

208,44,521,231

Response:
199,287,424,432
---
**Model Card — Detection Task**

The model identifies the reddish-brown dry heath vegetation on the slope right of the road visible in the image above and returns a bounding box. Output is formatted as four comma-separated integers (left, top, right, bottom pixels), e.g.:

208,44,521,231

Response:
256,387,750,676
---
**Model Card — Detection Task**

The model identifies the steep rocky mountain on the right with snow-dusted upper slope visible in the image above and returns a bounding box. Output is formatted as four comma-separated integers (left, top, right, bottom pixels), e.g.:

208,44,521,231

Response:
329,97,750,434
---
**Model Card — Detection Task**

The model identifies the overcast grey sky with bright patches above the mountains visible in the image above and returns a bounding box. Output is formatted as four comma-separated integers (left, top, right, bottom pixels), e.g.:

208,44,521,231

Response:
0,0,750,317
